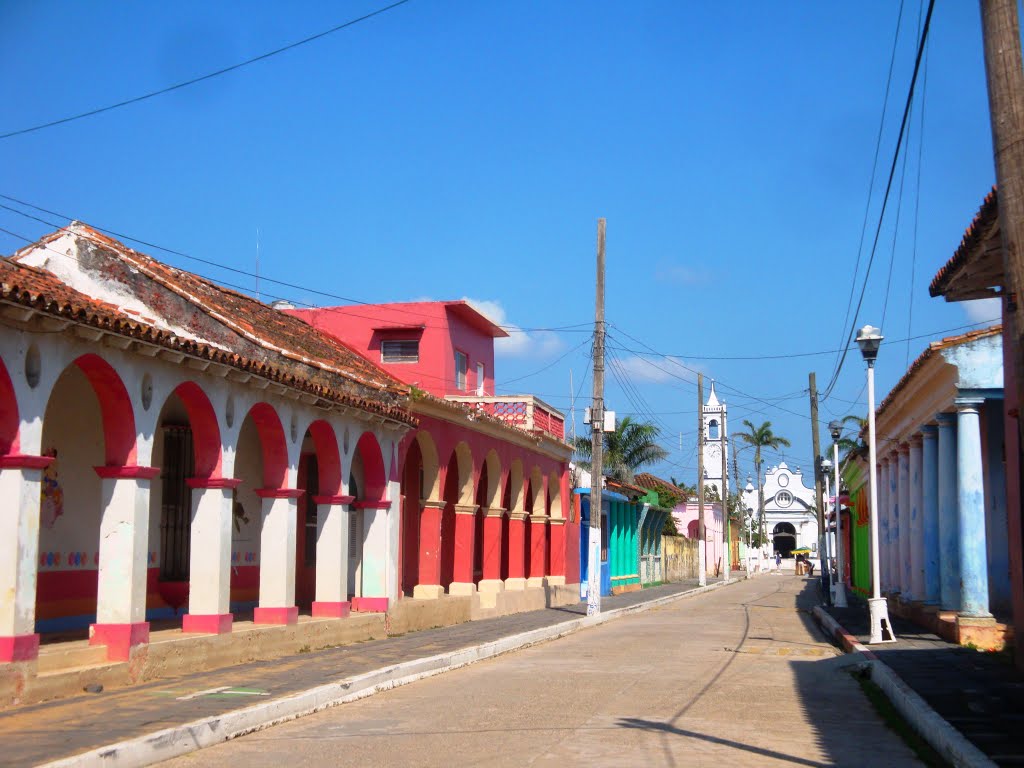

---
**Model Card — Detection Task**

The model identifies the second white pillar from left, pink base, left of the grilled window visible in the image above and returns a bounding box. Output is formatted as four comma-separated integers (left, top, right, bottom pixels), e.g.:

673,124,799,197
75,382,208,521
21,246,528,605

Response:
89,466,160,662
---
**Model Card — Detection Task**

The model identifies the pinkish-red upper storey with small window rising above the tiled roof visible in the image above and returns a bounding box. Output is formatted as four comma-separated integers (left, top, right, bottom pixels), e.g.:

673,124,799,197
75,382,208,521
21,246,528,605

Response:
288,301,507,397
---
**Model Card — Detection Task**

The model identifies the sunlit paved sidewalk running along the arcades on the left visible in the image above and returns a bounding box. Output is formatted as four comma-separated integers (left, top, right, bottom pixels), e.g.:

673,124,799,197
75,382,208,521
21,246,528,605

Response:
0,579,721,765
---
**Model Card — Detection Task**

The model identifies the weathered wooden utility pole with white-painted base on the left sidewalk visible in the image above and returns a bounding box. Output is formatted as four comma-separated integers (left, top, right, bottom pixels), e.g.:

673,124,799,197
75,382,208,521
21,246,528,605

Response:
587,219,604,616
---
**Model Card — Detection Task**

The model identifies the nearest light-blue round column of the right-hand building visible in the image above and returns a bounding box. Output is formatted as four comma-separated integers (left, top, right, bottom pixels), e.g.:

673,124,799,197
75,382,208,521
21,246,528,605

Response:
956,397,991,616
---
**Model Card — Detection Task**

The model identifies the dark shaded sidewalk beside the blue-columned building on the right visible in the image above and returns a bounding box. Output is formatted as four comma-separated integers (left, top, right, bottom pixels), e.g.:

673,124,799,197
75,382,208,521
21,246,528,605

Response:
822,600,1024,766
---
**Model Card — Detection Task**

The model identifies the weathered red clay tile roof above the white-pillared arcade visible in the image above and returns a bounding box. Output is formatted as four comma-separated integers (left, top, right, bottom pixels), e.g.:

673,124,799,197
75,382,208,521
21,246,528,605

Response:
0,236,416,424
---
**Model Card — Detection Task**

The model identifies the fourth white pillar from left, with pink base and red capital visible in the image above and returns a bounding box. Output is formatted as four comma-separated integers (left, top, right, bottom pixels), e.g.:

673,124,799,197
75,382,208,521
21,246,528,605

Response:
253,488,303,624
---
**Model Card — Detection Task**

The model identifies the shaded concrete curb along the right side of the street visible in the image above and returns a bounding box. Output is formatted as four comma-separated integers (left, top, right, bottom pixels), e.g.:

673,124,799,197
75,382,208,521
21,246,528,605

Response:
812,605,995,768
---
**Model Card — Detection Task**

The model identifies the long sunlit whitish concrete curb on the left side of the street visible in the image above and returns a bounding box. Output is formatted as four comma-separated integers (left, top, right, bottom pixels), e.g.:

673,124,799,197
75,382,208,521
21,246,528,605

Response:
43,579,740,768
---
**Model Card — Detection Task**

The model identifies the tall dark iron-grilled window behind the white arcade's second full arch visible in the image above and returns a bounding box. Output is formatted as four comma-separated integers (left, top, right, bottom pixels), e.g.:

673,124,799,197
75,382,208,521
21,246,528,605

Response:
160,426,195,582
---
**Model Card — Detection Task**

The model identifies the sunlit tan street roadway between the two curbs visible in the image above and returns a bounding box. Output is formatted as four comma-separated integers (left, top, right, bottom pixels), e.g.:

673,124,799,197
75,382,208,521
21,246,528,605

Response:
166,574,918,768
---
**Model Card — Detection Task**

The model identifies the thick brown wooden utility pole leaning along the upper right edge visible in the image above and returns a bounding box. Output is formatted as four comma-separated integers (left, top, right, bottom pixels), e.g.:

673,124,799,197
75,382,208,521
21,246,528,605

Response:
981,0,1024,466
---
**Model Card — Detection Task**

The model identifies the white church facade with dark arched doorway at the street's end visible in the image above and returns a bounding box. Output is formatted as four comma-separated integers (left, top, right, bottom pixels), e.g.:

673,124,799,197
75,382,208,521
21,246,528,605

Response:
743,462,818,557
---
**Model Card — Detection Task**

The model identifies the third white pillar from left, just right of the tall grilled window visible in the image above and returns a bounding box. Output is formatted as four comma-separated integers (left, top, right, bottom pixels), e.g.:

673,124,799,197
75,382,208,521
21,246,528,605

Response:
181,477,242,635
